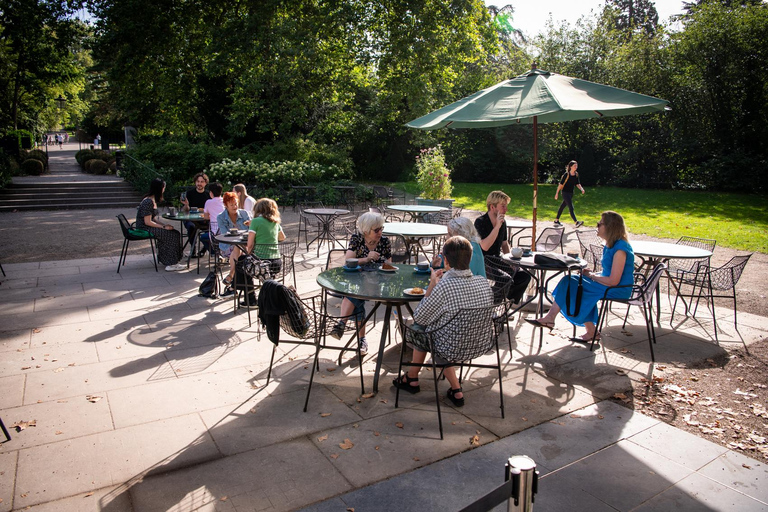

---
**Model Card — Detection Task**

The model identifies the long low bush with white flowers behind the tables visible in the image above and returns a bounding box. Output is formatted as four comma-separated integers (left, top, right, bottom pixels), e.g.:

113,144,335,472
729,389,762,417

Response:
206,158,351,187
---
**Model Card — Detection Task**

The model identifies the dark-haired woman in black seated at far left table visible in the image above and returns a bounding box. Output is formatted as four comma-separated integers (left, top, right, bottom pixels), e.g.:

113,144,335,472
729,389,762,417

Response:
136,178,187,272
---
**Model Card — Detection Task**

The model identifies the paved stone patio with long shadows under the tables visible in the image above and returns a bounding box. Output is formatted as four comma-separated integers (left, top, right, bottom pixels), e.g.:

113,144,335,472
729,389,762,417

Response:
0,235,768,512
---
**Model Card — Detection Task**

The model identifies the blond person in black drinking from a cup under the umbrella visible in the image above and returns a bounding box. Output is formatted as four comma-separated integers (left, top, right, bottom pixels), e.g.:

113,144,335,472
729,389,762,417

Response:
475,190,531,304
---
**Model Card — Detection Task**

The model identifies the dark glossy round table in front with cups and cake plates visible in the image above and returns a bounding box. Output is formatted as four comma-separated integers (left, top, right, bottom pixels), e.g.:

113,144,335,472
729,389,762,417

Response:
317,265,430,393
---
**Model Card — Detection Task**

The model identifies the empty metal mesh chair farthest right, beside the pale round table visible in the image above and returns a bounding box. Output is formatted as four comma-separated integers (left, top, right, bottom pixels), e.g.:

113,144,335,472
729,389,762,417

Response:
672,254,752,341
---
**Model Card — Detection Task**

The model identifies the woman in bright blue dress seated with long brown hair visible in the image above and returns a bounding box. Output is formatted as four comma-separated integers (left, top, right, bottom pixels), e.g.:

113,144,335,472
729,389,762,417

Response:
525,211,635,342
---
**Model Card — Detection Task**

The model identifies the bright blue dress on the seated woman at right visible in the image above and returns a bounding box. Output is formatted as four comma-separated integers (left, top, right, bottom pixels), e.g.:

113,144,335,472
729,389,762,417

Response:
554,240,635,327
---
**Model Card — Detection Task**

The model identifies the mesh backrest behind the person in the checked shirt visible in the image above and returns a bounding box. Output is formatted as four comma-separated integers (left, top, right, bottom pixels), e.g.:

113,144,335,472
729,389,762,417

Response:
427,305,497,362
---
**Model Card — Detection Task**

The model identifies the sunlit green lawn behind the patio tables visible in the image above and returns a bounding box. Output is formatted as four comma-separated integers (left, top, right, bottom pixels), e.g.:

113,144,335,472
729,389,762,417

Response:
390,183,768,253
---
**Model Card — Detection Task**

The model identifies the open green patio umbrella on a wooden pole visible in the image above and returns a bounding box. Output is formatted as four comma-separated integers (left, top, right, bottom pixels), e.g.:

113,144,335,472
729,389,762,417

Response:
406,63,669,248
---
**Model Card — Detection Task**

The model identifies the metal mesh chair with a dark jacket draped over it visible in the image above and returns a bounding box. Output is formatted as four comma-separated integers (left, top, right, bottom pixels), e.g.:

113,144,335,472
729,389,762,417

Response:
262,285,365,412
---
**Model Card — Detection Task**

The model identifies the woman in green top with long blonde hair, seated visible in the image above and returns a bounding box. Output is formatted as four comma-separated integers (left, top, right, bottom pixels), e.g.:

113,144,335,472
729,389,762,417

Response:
242,197,285,306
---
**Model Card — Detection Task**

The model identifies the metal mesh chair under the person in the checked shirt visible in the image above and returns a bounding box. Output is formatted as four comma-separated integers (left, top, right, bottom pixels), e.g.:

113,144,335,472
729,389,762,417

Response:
395,305,504,439
